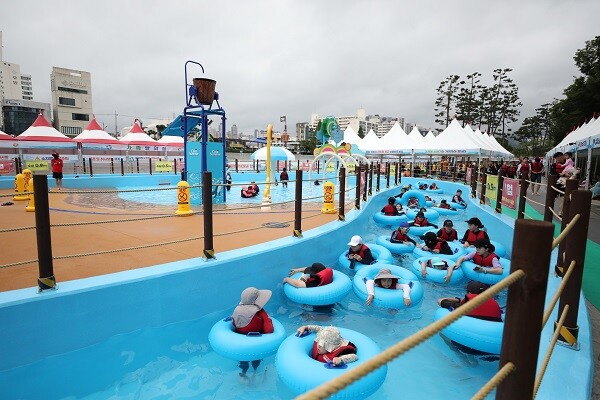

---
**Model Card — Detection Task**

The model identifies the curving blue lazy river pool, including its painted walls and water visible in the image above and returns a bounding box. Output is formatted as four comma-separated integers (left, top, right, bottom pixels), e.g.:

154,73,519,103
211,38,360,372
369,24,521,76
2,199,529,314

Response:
0,179,589,399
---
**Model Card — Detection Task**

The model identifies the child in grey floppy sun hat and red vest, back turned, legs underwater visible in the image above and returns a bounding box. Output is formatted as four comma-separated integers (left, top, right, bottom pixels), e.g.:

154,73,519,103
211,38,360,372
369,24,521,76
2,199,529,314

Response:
232,287,274,378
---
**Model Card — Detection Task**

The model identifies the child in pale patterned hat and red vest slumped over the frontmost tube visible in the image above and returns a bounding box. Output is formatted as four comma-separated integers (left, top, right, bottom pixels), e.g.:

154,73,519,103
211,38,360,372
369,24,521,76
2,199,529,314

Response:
296,325,358,365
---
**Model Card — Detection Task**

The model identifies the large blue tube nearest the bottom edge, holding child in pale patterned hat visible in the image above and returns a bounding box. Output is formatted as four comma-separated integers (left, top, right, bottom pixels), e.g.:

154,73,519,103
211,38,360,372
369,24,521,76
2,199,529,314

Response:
275,328,387,399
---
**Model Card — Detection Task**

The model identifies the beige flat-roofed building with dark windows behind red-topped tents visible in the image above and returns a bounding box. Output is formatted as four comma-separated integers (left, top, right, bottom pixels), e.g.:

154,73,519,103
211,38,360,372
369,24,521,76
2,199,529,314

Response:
50,67,93,137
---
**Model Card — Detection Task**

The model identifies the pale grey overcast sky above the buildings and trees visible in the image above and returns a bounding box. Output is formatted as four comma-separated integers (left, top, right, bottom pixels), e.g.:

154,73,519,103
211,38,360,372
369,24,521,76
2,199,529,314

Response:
0,0,600,133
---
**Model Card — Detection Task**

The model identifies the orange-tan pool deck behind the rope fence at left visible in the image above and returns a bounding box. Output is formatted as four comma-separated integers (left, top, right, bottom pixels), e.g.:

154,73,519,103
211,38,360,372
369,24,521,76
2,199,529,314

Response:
0,189,340,291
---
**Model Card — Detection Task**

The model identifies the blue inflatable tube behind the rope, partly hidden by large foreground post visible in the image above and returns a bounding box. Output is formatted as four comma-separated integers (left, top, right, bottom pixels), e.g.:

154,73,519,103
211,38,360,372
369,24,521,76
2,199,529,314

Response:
433,308,504,354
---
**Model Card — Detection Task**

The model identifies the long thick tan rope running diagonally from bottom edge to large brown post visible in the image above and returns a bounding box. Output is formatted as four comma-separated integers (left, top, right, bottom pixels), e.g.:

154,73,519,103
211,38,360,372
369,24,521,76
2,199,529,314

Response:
297,269,525,400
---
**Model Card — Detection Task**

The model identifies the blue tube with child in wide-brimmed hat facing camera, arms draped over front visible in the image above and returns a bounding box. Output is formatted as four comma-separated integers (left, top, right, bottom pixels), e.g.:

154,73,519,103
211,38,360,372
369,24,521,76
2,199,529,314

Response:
352,264,423,309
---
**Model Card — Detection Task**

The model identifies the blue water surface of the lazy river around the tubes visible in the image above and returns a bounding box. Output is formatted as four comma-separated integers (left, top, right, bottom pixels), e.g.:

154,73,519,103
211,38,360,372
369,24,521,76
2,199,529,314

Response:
0,191,505,399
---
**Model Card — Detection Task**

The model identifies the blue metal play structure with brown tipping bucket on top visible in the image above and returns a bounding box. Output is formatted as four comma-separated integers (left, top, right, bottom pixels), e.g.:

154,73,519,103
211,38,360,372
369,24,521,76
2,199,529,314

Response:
162,60,227,204
